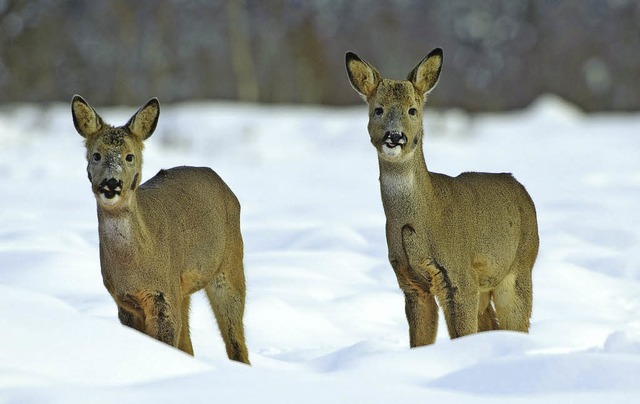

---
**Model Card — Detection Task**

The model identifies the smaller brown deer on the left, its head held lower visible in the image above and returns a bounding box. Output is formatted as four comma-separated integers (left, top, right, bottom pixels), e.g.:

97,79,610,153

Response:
71,95,250,364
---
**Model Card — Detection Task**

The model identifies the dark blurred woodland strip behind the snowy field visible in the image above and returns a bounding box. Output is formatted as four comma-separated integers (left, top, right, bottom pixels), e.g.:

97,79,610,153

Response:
0,0,640,112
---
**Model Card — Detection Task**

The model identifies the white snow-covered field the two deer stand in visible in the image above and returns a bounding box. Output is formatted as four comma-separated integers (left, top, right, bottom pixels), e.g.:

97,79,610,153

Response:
0,97,640,403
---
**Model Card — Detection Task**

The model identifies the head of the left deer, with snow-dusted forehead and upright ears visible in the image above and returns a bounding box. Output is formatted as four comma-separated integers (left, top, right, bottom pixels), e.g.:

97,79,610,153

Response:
71,95,160,209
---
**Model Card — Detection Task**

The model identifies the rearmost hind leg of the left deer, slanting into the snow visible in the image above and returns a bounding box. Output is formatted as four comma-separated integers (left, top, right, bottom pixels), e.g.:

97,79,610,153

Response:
205,254,249,364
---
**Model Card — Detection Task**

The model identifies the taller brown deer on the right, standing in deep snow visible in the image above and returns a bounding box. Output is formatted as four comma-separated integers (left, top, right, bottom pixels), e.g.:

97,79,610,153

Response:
345,48,539,348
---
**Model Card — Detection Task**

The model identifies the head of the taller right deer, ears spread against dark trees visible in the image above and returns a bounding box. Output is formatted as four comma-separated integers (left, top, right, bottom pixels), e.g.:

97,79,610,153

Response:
346,48,442,162
